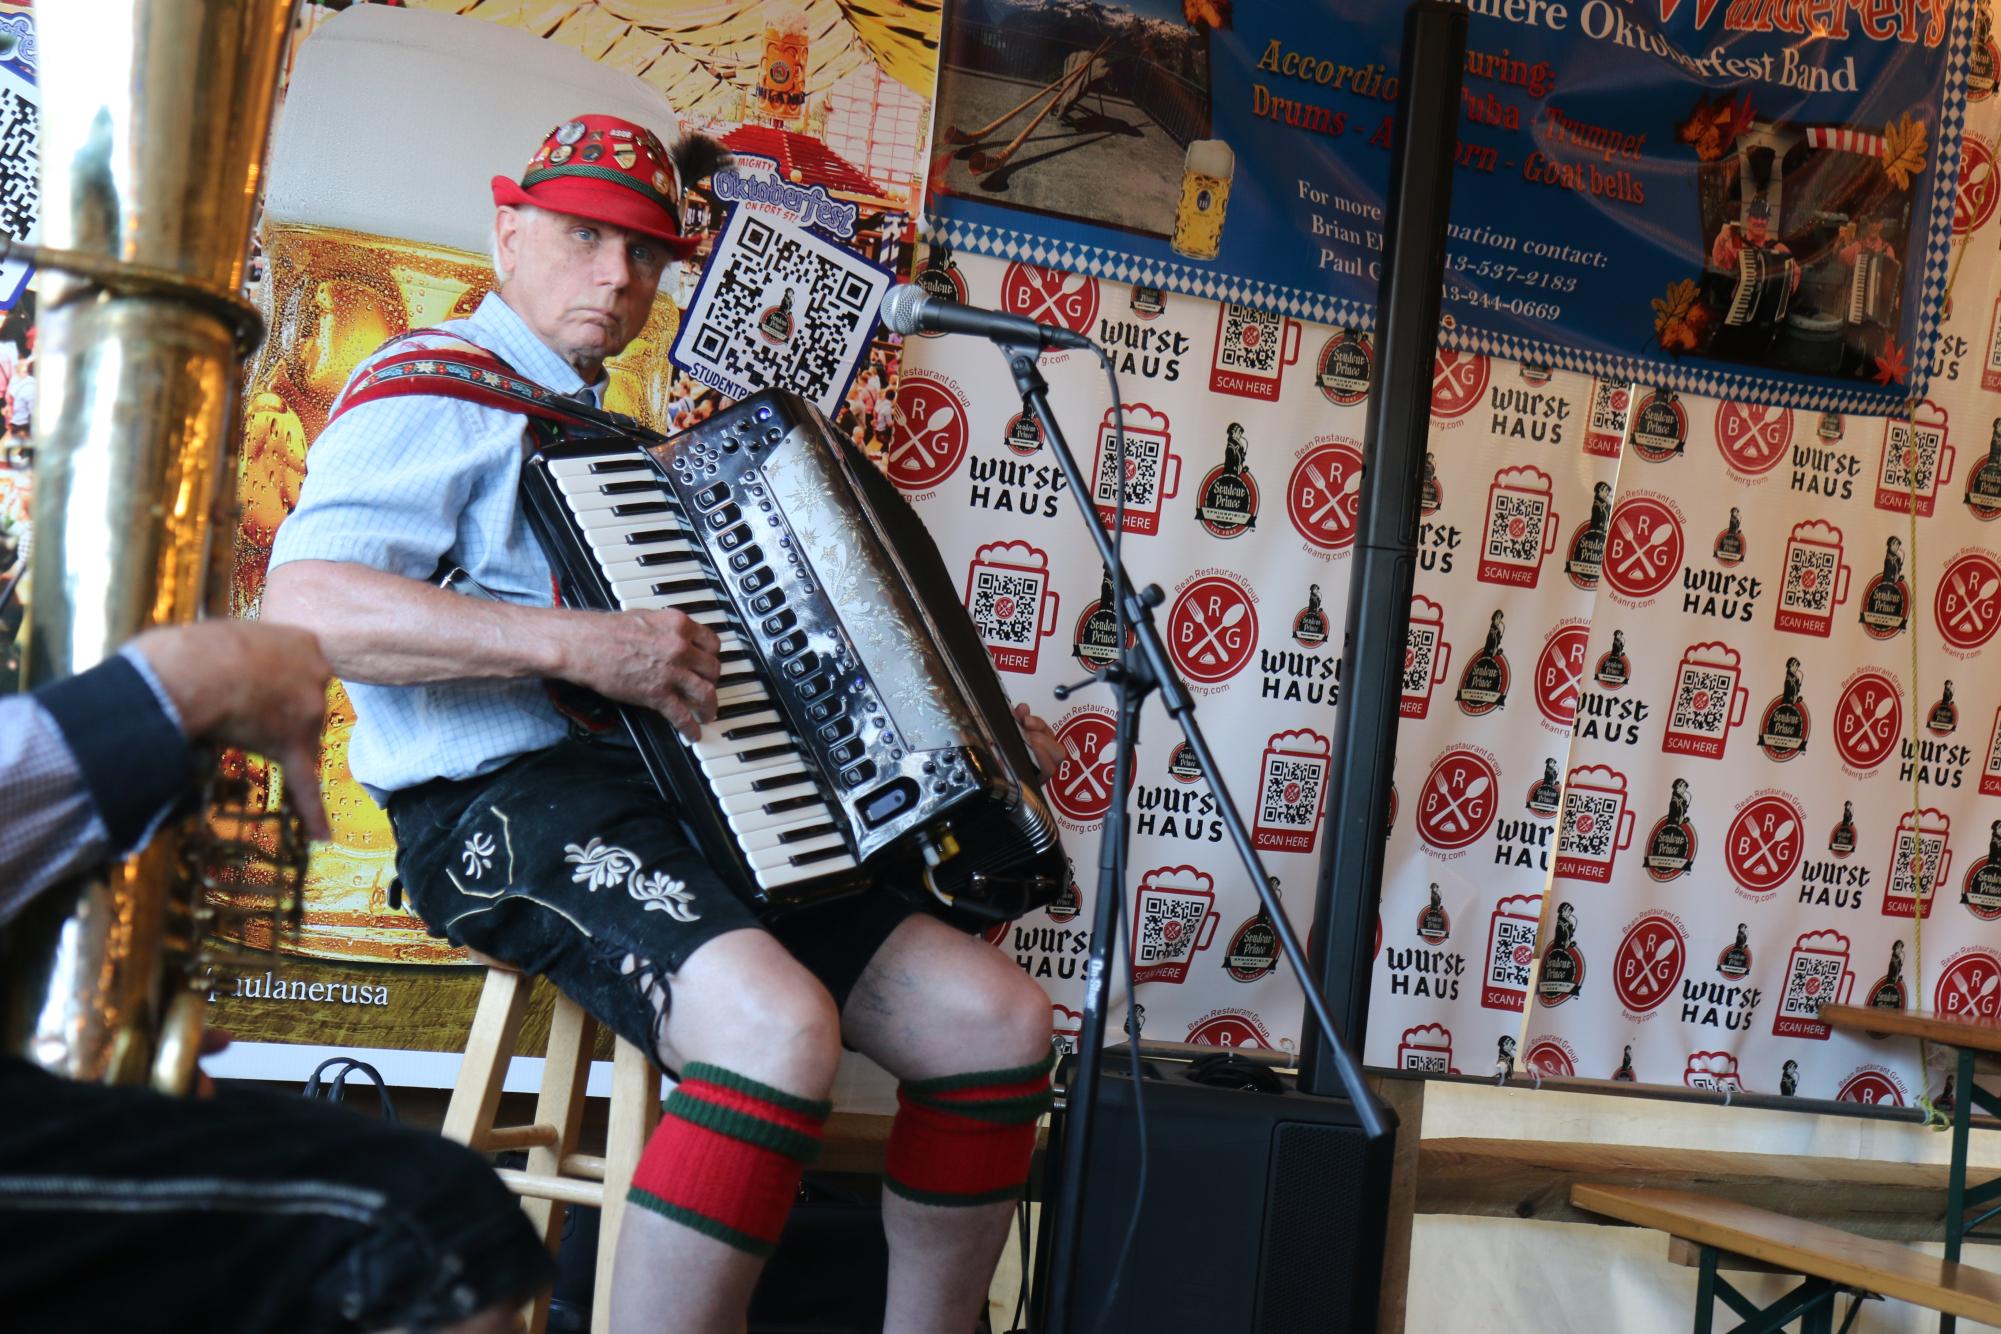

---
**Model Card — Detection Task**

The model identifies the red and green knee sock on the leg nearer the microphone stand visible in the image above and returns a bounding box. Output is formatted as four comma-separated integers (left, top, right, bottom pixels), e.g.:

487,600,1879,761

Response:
882,1052,1057,1204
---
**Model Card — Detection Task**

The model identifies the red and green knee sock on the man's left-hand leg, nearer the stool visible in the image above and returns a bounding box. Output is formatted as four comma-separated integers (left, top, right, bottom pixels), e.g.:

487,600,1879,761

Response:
626,1062,832,1256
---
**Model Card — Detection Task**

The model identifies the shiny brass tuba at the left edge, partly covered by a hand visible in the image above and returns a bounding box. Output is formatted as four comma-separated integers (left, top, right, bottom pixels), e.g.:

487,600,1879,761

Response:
0,0,302,1092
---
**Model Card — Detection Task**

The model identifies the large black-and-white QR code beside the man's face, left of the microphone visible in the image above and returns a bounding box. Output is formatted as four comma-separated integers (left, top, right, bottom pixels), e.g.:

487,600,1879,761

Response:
674,206,888,414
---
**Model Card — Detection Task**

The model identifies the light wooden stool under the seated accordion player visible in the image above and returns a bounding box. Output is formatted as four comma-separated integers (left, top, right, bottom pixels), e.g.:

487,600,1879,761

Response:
444,954,660,1334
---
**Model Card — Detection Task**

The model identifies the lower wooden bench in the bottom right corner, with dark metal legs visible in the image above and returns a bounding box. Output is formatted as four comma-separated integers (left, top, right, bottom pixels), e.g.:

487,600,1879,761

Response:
1571,1184,2001,1334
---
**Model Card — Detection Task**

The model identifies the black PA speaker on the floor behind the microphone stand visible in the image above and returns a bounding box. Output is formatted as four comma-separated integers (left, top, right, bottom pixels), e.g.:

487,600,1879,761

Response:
1035,1052,1395,1334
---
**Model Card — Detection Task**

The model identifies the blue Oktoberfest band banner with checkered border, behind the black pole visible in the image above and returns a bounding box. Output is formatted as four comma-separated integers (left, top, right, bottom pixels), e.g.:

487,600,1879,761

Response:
928,0,1968,412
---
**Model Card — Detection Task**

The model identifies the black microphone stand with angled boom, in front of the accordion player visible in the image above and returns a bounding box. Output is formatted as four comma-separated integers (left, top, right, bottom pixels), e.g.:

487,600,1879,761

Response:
998,342,1397,1334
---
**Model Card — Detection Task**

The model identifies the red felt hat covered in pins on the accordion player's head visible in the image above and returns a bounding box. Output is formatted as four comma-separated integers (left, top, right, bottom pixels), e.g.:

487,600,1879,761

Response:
492,116,714,260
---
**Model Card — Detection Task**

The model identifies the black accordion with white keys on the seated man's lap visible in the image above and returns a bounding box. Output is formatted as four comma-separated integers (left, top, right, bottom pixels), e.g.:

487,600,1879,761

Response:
522,390,1067,922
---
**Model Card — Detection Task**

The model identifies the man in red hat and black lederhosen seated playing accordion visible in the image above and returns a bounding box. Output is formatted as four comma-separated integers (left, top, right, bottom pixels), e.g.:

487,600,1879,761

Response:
264,116,1061,1334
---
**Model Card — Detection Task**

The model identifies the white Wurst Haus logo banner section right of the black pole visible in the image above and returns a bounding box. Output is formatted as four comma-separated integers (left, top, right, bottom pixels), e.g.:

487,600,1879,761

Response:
1369,47,2001,1106
